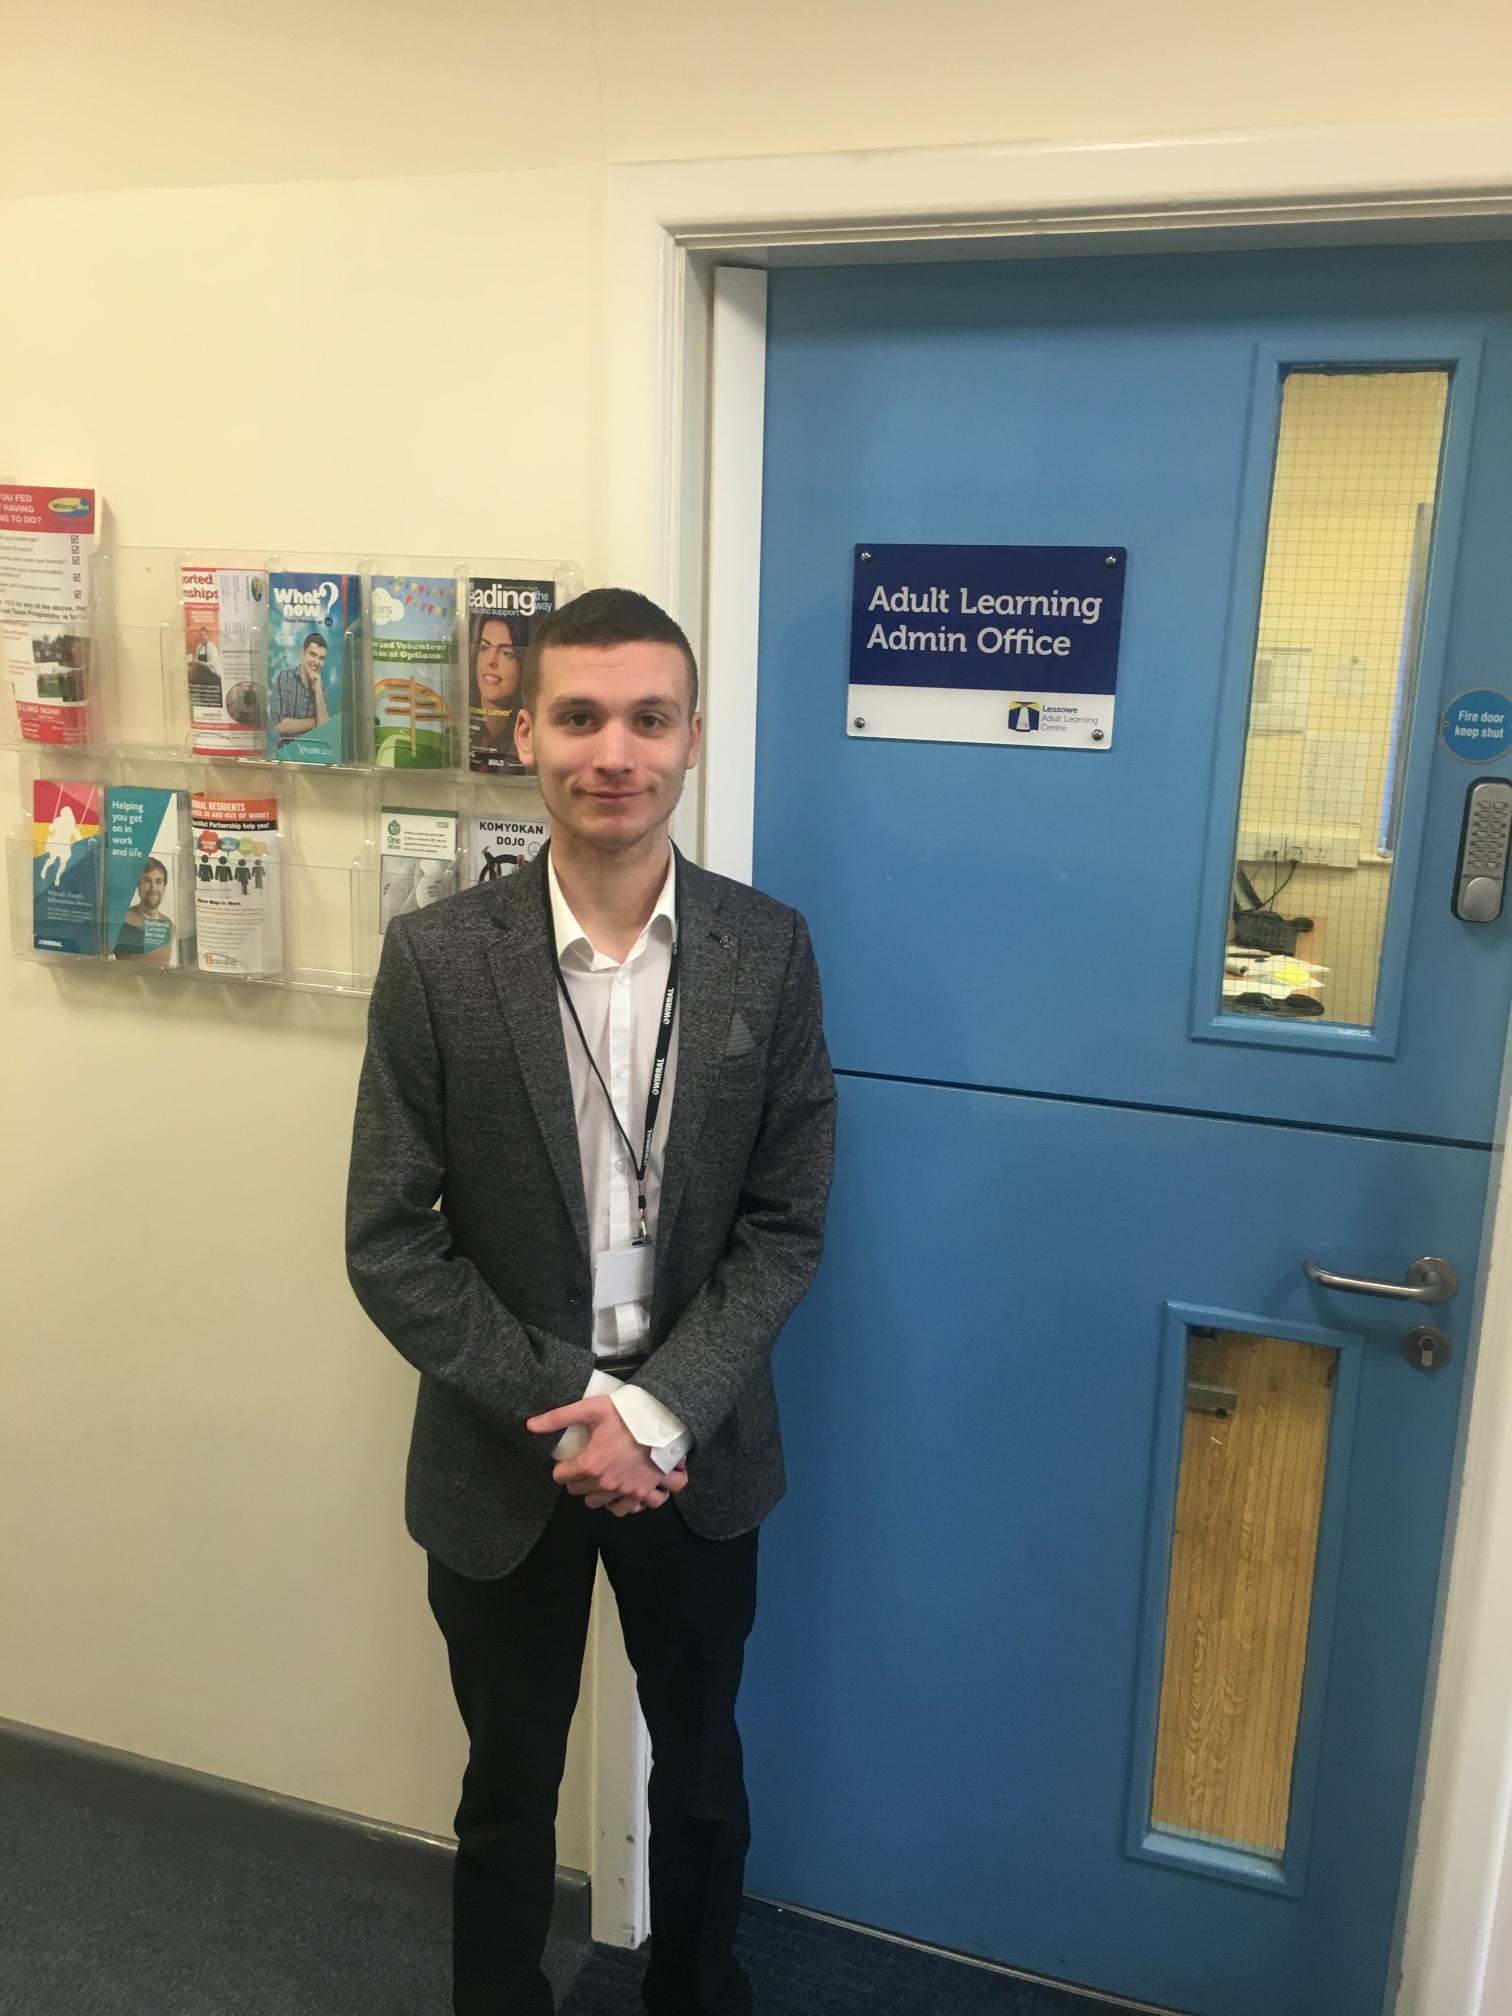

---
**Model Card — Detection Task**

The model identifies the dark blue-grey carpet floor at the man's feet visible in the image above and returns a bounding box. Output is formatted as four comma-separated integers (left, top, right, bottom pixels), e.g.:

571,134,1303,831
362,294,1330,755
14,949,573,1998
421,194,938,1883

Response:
0,1784,1137,2016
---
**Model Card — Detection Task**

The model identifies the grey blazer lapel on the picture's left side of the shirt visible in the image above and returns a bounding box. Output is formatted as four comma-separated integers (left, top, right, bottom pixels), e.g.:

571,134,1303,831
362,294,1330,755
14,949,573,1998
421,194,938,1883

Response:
488,851,588,1260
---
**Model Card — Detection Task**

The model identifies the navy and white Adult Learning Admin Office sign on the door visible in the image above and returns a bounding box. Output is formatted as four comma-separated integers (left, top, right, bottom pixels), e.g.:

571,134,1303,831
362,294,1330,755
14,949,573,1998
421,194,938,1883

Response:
847,544,1129,750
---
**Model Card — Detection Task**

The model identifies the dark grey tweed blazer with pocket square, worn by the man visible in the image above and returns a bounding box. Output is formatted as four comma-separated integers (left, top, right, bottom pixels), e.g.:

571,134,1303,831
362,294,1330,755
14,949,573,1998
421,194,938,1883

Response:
347,855,835,1577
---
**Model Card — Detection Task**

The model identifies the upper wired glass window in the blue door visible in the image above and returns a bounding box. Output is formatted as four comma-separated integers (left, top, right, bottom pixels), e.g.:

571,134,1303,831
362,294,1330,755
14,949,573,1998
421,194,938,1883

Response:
1222,369,1450,1026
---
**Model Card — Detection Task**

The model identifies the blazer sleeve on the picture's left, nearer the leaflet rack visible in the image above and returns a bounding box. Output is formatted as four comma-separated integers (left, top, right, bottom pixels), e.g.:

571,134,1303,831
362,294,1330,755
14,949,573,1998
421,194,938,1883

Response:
347,917,593,1445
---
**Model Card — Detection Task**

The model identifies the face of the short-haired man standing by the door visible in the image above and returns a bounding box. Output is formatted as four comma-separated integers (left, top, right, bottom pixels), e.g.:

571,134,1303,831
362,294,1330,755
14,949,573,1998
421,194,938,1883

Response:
516,643,704,853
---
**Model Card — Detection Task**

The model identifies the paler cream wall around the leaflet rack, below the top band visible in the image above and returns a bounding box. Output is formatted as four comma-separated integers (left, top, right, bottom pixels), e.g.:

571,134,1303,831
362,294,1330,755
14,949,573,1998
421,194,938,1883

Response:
0,169,601,1867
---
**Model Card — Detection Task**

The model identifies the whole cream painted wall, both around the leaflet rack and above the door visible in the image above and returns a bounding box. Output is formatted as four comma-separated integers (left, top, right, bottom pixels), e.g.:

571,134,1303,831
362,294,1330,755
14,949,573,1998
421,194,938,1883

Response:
0,0,1512,1895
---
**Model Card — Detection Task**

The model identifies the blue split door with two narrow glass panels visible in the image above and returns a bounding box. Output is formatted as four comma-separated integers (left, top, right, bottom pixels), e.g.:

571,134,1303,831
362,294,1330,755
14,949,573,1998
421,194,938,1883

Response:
742,248,1512,2016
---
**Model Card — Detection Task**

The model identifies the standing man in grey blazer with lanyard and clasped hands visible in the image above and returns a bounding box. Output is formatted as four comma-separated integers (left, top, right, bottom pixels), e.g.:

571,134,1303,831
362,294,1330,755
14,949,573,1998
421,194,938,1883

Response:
347,589,835,2016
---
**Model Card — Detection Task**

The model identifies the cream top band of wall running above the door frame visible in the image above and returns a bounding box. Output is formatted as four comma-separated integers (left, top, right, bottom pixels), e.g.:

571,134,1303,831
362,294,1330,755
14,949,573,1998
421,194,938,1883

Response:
0,0,1512,194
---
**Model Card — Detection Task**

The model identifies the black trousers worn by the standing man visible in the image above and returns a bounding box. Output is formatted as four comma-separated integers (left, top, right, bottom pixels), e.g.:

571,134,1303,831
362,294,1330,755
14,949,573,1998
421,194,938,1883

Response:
429,1492,756,2016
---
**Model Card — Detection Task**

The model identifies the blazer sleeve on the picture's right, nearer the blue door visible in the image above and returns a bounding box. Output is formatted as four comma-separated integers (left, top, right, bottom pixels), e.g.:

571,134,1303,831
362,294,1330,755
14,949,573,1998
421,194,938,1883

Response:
631,913,835,1441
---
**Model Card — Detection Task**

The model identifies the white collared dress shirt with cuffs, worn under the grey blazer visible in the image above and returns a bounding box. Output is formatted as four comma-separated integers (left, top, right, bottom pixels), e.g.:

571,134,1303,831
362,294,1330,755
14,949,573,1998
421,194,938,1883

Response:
546,853,694,1472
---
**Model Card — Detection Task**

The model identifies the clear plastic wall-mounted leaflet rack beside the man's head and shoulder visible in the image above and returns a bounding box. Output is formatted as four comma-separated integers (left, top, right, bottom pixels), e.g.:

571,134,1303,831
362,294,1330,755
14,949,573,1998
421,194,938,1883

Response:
0,548,583,998
